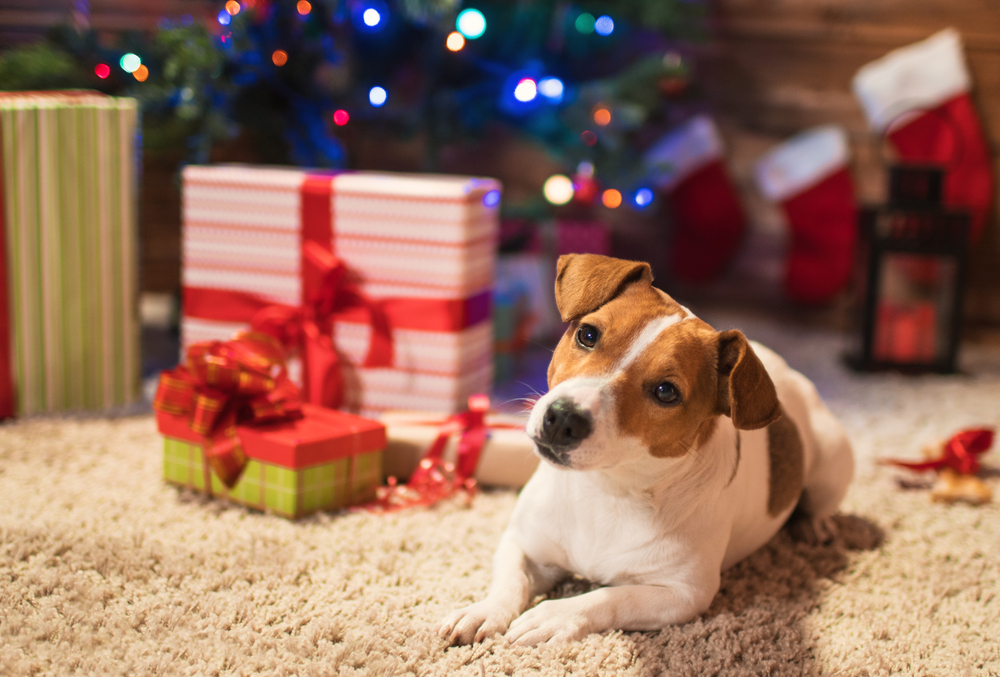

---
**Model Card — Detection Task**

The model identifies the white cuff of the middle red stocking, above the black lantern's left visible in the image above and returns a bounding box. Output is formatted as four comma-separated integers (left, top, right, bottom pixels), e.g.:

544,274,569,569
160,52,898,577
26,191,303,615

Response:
754,125,848,202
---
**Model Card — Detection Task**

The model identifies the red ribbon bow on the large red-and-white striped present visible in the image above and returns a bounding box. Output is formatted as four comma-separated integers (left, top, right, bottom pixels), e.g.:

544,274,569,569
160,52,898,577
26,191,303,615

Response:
250,241,392,409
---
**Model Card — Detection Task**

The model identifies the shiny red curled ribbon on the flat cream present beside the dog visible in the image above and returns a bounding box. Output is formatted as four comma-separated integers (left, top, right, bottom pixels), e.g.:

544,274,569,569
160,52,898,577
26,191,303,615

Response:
363,395,518,512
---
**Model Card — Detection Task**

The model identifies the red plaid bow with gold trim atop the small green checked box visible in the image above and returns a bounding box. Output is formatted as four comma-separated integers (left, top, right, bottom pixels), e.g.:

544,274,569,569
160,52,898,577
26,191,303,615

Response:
153,332,302,488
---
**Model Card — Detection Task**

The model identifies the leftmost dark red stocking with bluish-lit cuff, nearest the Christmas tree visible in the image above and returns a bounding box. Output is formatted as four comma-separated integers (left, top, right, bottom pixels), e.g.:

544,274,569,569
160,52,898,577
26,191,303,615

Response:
646,115,745,282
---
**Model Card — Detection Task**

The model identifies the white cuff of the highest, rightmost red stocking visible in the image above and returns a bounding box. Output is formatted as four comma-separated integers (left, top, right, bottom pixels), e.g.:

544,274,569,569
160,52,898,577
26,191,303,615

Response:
851,28,971,132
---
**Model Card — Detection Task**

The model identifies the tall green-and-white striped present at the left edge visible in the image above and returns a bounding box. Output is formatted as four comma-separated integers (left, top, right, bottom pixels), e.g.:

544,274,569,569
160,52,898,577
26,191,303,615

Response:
0,92,141,417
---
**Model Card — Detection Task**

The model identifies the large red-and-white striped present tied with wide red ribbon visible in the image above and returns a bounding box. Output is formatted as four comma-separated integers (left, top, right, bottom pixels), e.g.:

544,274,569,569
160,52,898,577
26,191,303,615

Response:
181,166,499,413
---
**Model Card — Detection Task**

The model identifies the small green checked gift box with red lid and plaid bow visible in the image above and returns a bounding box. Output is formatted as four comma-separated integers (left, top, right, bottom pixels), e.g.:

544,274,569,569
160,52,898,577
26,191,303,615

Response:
154,333,386,519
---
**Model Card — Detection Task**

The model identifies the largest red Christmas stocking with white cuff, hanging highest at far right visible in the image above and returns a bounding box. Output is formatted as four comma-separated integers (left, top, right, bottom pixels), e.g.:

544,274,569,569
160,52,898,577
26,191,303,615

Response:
853,29,993,242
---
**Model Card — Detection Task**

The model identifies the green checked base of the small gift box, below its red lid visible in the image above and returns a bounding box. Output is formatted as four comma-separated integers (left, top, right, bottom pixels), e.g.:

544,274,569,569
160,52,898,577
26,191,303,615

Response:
163,437,382,519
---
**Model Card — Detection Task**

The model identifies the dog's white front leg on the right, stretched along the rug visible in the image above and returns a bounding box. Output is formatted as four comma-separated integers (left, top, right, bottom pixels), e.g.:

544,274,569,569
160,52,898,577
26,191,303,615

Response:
504,580,719,646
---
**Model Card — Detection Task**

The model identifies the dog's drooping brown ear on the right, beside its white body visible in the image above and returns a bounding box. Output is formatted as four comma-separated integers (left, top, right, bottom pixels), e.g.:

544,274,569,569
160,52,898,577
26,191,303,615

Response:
717,329,781,430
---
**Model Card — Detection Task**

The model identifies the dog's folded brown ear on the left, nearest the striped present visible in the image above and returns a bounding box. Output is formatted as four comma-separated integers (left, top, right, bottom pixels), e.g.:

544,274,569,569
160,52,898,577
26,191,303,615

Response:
556,254,653,322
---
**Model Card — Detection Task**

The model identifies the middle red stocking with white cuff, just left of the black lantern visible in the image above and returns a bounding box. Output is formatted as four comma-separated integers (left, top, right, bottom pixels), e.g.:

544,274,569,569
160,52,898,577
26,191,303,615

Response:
755,126,857,305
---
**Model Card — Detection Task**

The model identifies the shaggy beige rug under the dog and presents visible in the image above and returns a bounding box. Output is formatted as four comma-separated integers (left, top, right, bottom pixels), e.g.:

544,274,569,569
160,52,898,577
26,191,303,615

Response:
0,320,1000,677
